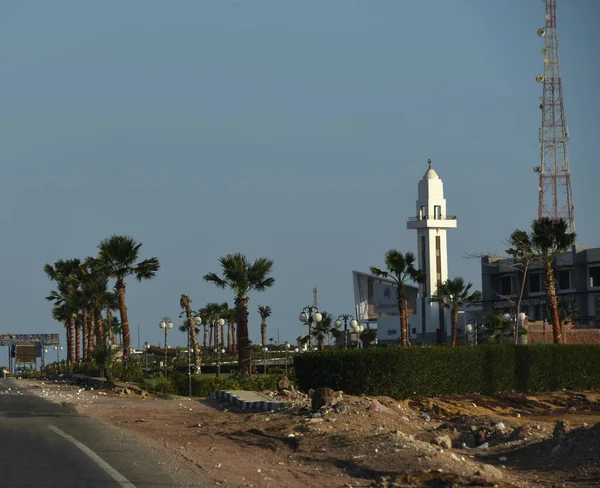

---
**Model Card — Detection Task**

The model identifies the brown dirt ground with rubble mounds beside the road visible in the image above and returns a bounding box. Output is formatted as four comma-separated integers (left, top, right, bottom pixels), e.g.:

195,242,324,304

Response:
20,380,600,488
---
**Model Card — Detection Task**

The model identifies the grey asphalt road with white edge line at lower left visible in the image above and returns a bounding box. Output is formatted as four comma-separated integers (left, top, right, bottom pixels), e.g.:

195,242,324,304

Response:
0,379,214,488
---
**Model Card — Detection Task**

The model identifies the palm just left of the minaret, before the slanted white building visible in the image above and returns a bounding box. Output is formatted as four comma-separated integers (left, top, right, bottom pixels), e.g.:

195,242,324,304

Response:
370,249,425,347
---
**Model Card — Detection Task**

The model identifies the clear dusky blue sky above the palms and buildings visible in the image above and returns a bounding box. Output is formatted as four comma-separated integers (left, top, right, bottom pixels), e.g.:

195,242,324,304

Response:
0,0,600,352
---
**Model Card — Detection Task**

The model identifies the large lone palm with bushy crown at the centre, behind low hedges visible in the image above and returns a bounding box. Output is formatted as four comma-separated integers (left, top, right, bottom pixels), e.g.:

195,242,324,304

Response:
204,253,275,374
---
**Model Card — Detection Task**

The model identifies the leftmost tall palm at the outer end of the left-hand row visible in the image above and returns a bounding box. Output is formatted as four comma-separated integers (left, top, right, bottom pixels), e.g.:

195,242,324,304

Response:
44,259,81,363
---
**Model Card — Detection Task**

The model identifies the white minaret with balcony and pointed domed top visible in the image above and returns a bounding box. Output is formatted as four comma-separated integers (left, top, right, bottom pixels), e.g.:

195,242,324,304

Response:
406,159,457,343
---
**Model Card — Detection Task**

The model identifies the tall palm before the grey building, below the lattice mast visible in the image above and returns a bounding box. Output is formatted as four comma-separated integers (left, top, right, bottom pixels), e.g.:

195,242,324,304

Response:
531,217,576,344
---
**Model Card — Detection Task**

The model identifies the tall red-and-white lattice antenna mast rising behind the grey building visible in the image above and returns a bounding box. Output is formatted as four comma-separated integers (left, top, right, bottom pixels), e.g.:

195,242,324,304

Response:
534,0,575,232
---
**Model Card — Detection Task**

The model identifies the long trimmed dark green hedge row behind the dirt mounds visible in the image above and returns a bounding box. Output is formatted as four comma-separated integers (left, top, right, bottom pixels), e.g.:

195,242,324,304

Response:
294,344,600,399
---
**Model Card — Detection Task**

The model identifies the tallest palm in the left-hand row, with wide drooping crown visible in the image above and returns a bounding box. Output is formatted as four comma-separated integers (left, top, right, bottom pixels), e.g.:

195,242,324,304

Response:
93,235,160,359
